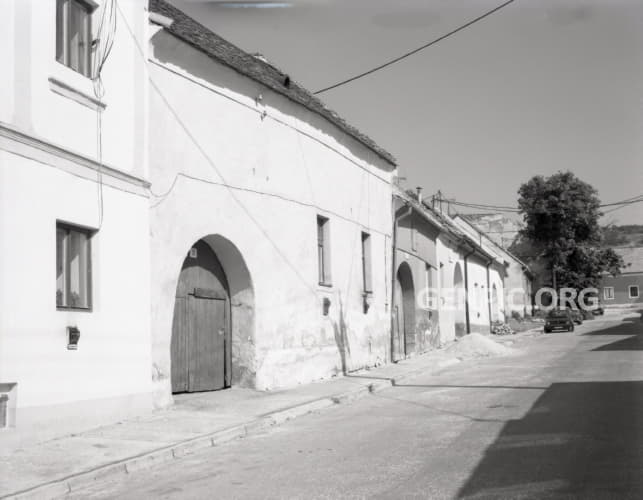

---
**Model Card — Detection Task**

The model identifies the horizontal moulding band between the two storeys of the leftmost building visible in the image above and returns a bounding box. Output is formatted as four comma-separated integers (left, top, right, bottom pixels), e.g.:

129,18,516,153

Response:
0,122,150,198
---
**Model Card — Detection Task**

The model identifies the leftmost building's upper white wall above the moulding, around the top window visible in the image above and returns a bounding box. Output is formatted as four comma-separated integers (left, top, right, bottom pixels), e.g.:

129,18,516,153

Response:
0,0,147,176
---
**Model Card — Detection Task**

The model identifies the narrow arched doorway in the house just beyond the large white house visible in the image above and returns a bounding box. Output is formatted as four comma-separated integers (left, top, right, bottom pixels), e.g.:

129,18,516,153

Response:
392,262,415,361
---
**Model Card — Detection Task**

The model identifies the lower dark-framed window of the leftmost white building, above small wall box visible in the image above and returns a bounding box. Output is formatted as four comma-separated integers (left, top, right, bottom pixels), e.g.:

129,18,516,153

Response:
56,222,92,309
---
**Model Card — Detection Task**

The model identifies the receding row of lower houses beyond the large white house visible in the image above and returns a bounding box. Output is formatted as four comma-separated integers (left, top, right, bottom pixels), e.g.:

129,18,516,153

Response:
391,189,507,352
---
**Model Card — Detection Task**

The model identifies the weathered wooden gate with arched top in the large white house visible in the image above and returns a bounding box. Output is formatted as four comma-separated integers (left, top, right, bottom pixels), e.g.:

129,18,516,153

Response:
171,240,232,393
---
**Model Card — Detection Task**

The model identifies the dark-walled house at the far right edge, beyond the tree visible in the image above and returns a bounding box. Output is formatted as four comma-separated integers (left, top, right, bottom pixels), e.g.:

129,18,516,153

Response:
600,247,643,307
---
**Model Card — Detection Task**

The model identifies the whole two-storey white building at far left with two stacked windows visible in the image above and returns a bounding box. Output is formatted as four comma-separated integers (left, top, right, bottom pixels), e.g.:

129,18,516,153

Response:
0,0,152,445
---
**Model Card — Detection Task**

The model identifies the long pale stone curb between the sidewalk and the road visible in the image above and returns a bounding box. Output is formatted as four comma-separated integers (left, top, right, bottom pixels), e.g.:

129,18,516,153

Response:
0,360,456,500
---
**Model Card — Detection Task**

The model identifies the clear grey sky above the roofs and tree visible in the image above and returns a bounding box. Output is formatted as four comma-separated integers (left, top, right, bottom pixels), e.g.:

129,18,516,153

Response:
171,0,643,224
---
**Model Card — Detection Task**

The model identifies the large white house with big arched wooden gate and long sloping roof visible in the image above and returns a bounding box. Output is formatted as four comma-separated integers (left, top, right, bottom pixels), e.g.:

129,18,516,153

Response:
149,0,396,405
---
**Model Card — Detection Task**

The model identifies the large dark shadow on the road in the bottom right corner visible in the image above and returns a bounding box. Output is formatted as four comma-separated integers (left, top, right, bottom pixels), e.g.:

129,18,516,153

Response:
458,381,643,498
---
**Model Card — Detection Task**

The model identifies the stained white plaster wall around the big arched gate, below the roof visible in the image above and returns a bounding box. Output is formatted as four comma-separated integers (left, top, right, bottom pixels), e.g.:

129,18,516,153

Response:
150,31,394,405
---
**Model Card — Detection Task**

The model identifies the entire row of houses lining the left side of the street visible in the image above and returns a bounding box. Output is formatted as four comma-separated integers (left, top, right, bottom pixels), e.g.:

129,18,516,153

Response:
0,0,531,441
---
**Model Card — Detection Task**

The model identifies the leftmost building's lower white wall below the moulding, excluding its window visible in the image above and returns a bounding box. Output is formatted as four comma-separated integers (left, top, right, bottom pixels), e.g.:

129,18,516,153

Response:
0,151,151,414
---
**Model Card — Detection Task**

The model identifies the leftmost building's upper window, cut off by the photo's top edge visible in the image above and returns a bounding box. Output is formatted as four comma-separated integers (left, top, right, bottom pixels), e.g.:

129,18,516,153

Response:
56,0,94,77
